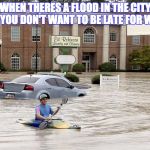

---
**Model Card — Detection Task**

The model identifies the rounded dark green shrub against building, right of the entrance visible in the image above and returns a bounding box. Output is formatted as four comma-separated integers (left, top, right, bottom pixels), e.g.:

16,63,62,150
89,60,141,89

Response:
99,62,116,72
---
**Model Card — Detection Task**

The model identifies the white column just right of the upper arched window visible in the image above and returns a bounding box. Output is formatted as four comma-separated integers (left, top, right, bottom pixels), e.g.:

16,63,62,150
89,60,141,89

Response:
102,25,109,63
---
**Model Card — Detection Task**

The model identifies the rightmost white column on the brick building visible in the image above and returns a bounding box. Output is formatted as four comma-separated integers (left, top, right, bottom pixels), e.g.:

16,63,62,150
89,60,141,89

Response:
120,26,126,70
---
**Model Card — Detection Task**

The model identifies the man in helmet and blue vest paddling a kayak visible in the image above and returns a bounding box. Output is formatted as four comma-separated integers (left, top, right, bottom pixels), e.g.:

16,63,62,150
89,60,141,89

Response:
35,94,60,121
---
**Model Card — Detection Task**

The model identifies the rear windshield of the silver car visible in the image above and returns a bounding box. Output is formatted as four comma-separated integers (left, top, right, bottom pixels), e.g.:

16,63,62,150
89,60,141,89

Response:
12,76,39,83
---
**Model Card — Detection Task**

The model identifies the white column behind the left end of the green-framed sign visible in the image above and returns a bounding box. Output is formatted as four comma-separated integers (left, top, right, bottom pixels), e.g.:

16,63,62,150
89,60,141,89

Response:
52,25,59,70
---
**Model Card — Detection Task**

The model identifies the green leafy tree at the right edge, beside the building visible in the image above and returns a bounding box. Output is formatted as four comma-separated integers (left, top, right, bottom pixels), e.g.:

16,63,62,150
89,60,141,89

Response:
129,46,150,71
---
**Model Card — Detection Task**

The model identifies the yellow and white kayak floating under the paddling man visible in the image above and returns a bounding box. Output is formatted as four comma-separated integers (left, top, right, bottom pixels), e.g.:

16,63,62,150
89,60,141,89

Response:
17,119,81,129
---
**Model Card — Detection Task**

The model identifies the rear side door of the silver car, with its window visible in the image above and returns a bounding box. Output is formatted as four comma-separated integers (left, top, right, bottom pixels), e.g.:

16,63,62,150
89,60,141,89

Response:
46,78,62,98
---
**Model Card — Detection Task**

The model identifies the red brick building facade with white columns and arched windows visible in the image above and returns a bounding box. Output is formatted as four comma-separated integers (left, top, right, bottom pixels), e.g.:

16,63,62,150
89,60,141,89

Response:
0,24,150,71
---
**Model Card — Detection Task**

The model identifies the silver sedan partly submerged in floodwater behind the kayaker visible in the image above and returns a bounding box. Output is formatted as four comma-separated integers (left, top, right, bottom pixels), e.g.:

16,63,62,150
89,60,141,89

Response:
0,74,86,99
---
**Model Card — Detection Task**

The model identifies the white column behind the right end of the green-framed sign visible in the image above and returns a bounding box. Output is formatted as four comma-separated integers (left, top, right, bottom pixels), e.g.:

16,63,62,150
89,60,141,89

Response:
72,23,78,64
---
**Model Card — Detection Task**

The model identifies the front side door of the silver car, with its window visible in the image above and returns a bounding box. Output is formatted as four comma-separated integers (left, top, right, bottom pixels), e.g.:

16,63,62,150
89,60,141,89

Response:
56,78,77,97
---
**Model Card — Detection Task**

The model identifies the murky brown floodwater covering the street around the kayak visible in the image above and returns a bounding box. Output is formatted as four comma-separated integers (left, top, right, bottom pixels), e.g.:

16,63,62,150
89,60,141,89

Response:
0,73,150,150
